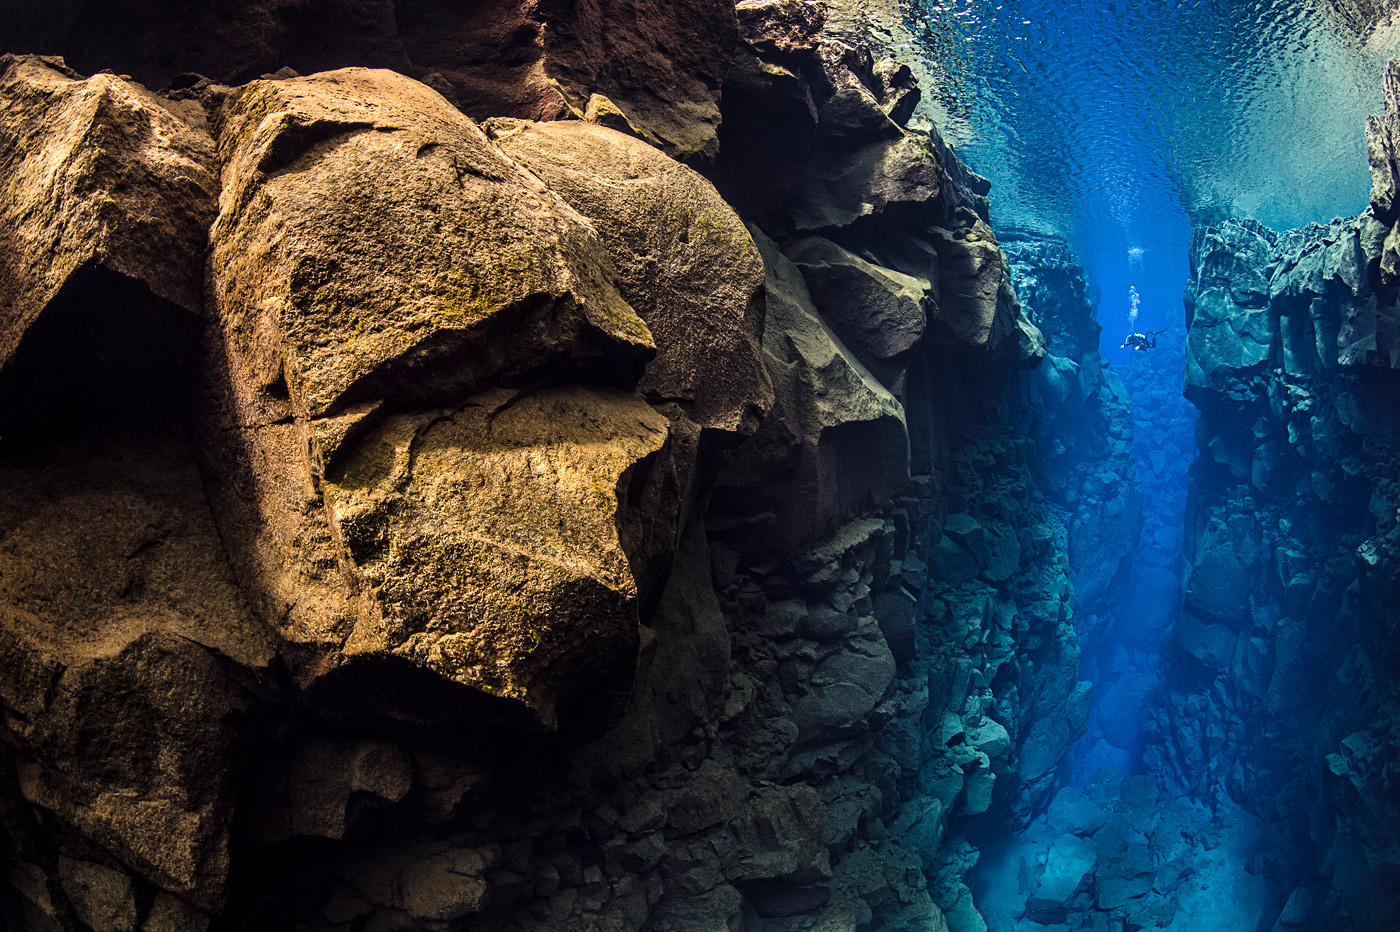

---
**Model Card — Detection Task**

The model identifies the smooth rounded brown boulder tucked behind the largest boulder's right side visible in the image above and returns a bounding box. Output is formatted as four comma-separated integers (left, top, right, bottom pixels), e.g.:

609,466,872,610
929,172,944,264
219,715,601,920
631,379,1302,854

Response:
486,120,773,434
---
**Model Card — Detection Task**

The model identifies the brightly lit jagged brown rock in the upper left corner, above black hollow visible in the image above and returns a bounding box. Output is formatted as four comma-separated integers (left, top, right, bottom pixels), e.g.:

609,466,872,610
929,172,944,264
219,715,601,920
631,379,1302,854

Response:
0,56,217,365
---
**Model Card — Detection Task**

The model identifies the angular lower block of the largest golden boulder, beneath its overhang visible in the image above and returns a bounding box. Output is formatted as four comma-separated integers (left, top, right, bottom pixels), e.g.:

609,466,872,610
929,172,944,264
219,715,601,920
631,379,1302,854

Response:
325,388,676,725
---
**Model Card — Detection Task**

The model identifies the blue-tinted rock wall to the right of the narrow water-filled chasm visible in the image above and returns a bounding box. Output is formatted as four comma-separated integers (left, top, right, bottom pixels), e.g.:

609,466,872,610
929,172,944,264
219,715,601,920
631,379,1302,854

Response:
1151,66,1400,932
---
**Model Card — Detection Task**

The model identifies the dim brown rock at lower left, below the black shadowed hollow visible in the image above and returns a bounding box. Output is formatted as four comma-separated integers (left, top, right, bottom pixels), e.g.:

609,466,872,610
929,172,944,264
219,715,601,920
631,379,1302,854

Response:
0,428,270,908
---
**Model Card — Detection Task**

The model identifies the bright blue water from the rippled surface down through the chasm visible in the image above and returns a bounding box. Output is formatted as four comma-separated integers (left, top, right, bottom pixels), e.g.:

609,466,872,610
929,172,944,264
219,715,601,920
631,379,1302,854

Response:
890,0,1400,932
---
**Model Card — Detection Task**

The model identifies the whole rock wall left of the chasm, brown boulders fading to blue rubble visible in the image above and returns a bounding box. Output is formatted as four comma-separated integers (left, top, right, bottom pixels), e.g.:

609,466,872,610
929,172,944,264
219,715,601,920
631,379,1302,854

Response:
0,7,1130,932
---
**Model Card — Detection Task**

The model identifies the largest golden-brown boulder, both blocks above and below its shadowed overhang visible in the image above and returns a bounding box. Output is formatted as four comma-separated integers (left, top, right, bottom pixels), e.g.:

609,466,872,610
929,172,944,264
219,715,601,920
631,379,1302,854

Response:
206,69,675,725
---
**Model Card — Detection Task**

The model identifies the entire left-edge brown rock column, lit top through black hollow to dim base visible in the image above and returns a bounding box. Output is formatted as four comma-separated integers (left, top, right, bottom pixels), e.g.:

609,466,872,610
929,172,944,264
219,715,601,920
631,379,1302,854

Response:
0,57,257,907
